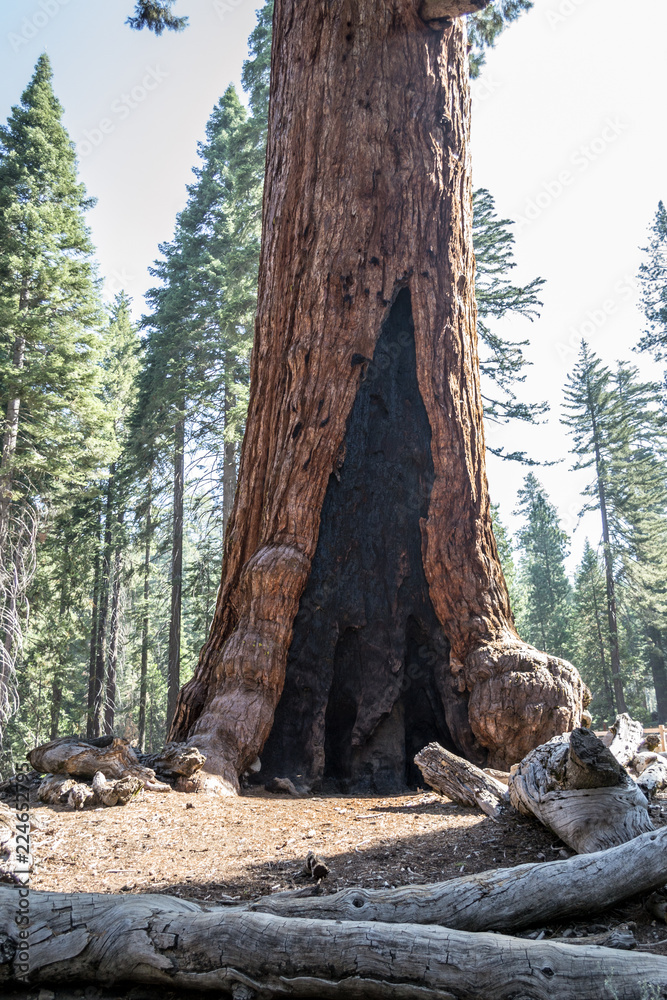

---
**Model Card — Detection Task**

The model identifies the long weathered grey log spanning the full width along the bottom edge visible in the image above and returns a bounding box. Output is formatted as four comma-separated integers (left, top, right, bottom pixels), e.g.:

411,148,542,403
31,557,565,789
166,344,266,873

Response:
0,888,667,1000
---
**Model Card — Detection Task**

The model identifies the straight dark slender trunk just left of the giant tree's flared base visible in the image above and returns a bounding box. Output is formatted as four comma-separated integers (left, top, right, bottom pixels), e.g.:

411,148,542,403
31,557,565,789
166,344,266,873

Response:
167,414,185,732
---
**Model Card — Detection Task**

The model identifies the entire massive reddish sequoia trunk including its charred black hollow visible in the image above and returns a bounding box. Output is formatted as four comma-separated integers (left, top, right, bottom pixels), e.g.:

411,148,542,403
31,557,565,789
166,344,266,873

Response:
170,0,584,790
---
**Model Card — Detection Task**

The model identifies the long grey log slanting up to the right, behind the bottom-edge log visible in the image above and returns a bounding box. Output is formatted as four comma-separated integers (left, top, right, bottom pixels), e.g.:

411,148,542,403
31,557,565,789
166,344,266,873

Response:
247,827,667,932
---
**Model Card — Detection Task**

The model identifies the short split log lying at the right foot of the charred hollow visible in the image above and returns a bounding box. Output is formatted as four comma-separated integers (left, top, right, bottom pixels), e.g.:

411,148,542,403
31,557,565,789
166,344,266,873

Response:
415,743,508,819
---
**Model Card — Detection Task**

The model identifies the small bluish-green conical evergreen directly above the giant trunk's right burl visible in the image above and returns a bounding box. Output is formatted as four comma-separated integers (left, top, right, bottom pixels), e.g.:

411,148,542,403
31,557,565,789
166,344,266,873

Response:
517,473,572,659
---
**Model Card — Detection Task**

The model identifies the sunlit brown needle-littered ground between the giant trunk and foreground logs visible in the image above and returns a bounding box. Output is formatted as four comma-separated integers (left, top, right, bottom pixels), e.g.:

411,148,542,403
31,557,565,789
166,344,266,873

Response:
7,790,667,1000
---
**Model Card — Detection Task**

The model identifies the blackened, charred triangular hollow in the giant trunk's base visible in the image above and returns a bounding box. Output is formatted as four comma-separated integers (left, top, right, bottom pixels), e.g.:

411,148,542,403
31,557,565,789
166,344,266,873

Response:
261,288,465,793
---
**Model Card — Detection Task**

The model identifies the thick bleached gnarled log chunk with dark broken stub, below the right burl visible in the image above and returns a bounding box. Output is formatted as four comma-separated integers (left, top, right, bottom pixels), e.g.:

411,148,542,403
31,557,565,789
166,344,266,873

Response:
509,729,653,854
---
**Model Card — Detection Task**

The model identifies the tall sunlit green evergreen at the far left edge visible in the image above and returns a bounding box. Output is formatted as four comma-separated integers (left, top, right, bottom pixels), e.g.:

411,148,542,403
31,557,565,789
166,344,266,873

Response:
0,55,109,734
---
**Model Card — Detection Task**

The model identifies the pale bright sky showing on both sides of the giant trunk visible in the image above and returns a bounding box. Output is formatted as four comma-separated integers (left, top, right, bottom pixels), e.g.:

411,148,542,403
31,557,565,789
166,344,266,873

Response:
0,0,667,568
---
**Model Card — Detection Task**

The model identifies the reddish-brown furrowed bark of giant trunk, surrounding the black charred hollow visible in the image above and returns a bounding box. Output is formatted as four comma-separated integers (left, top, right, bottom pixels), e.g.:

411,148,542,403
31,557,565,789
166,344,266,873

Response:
170,0,584,790
